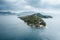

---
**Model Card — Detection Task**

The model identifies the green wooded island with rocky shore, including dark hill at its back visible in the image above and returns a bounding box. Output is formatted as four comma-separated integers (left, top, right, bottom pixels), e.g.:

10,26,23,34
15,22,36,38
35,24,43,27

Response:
18,13,52,28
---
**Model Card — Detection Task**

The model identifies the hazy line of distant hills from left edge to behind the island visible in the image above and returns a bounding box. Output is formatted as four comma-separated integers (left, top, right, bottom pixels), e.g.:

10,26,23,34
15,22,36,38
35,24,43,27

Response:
0,11,52,18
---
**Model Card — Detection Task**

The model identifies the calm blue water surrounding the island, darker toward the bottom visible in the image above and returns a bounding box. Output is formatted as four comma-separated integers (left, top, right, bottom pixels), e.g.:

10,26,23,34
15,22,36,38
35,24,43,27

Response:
0,15,60,40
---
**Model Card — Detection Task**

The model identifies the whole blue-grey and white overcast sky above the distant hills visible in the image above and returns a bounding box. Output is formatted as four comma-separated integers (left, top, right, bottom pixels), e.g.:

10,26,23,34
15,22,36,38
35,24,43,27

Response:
0,0,60,14
